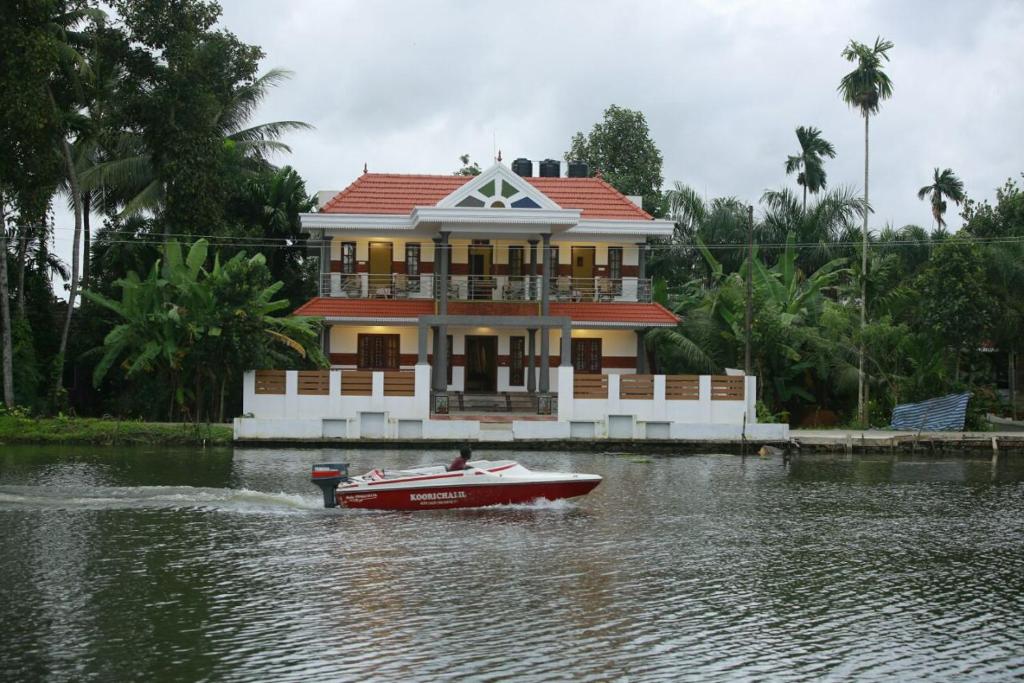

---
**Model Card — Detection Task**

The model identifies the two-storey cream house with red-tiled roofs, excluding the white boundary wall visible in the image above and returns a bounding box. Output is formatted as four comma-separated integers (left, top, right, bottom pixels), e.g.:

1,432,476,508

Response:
296,160,677,410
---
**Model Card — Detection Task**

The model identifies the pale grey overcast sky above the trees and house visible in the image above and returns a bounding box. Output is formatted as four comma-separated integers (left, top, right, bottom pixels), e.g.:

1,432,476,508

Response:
51,0,1024,258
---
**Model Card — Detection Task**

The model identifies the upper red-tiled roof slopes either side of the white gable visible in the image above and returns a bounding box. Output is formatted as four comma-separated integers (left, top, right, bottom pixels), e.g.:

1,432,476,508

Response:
321,173,651,220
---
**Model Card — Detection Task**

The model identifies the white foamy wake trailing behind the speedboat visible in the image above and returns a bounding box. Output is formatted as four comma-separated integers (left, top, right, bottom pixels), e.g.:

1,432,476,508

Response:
0,486,323,514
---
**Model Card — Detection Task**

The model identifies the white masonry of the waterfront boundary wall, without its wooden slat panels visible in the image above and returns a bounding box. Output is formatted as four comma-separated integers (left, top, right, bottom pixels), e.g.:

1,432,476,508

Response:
234,365,788,440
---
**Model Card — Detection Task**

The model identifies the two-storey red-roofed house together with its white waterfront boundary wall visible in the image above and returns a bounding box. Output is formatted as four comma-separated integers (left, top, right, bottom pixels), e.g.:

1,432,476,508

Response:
236,160,785,441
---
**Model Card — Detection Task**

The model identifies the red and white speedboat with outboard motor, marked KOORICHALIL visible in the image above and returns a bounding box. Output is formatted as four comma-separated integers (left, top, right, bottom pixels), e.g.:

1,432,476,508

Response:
312,460,601,510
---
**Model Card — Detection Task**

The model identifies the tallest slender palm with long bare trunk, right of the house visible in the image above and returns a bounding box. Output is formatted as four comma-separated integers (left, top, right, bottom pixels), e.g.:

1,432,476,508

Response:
839,36,894,424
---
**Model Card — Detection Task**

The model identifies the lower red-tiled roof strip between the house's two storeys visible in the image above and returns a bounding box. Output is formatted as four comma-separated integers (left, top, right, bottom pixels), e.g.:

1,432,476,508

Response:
295,297,679,327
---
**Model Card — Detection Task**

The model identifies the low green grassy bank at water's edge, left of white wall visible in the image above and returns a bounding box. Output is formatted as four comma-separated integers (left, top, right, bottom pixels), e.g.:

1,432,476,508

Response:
0,415,232,445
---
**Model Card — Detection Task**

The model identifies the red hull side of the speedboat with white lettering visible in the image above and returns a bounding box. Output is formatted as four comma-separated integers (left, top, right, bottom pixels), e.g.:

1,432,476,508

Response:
337,477,601,510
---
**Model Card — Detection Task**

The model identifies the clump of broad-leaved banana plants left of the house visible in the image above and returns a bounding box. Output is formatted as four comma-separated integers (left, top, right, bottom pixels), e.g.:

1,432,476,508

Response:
86,240,326,421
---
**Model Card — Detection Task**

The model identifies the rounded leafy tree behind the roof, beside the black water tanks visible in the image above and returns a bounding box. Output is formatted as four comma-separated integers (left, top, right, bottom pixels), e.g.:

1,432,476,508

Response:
565,104,664,216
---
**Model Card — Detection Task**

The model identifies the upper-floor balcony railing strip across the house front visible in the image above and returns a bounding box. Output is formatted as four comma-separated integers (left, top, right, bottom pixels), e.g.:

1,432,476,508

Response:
319,272,651,303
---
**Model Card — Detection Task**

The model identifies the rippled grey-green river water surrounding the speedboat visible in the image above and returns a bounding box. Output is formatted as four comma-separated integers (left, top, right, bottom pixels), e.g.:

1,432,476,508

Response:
0,446,1024,681
